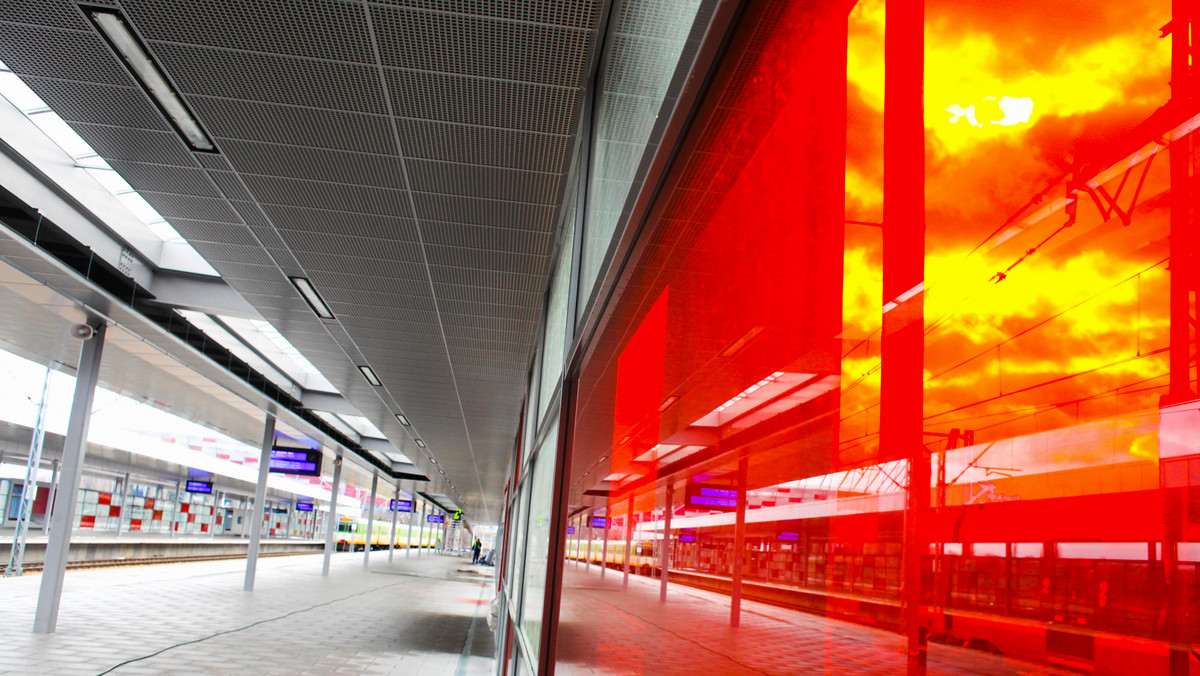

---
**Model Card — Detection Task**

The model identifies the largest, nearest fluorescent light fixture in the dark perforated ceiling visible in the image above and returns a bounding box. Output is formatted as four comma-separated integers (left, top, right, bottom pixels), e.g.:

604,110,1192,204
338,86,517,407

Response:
88,8,216,152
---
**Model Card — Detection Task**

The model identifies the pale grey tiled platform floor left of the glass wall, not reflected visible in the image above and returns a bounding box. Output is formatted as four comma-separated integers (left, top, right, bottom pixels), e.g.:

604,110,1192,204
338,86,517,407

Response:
0,551,496,676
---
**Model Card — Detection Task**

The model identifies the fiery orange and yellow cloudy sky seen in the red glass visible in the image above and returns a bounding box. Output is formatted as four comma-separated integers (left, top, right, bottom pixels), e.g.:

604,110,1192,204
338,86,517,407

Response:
842,0,1170,463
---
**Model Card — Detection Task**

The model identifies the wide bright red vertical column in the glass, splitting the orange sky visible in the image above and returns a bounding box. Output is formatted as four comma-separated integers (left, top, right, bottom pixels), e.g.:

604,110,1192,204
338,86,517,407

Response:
880,0,930,674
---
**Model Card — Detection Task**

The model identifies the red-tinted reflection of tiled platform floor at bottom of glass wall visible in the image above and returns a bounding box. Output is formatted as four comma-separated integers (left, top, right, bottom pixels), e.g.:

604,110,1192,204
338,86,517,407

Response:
557,562,1078,676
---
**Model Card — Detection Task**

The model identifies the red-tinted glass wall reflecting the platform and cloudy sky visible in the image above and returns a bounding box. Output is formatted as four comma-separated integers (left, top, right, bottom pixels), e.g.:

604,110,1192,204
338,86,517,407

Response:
528,0,1200,676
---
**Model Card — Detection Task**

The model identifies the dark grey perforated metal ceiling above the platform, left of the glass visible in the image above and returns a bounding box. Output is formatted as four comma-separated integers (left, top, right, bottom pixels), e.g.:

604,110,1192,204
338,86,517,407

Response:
0,0,599,522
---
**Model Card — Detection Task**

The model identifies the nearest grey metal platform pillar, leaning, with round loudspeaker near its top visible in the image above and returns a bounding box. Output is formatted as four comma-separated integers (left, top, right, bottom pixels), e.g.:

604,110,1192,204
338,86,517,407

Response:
34,322,106,634
